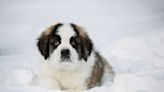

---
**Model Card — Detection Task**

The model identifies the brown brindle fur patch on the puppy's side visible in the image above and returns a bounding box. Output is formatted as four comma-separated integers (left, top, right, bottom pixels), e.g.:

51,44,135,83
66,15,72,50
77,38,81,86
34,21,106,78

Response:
88,53,104,88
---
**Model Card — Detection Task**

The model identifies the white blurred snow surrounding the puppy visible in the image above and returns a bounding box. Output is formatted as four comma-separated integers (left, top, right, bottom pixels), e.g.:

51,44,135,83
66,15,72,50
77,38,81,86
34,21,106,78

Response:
0,0,164,92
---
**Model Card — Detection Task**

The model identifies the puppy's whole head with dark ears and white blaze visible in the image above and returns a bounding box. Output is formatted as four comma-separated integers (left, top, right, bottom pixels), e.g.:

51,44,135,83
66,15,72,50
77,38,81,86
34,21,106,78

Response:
37,23,93,67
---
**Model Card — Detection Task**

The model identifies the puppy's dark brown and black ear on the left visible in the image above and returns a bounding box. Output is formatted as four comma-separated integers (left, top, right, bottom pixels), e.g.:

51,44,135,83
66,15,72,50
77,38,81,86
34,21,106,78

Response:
37,23,62,59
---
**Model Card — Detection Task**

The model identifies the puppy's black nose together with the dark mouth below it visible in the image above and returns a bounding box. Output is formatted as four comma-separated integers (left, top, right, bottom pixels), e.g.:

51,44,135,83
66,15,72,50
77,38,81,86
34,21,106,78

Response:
61,49,71,62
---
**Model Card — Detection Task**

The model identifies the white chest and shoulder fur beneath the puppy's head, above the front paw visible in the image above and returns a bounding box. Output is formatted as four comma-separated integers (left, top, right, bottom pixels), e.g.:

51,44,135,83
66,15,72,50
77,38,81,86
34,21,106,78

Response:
39,52,95,89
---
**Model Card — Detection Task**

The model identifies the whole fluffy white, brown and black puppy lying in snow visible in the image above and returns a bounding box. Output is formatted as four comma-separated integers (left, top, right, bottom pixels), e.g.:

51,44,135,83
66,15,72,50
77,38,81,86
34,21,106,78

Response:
37,23,114,90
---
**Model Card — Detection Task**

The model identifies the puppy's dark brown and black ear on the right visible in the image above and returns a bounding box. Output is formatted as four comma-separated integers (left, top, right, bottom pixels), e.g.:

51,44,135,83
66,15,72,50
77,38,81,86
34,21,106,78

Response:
71,23,93,61
